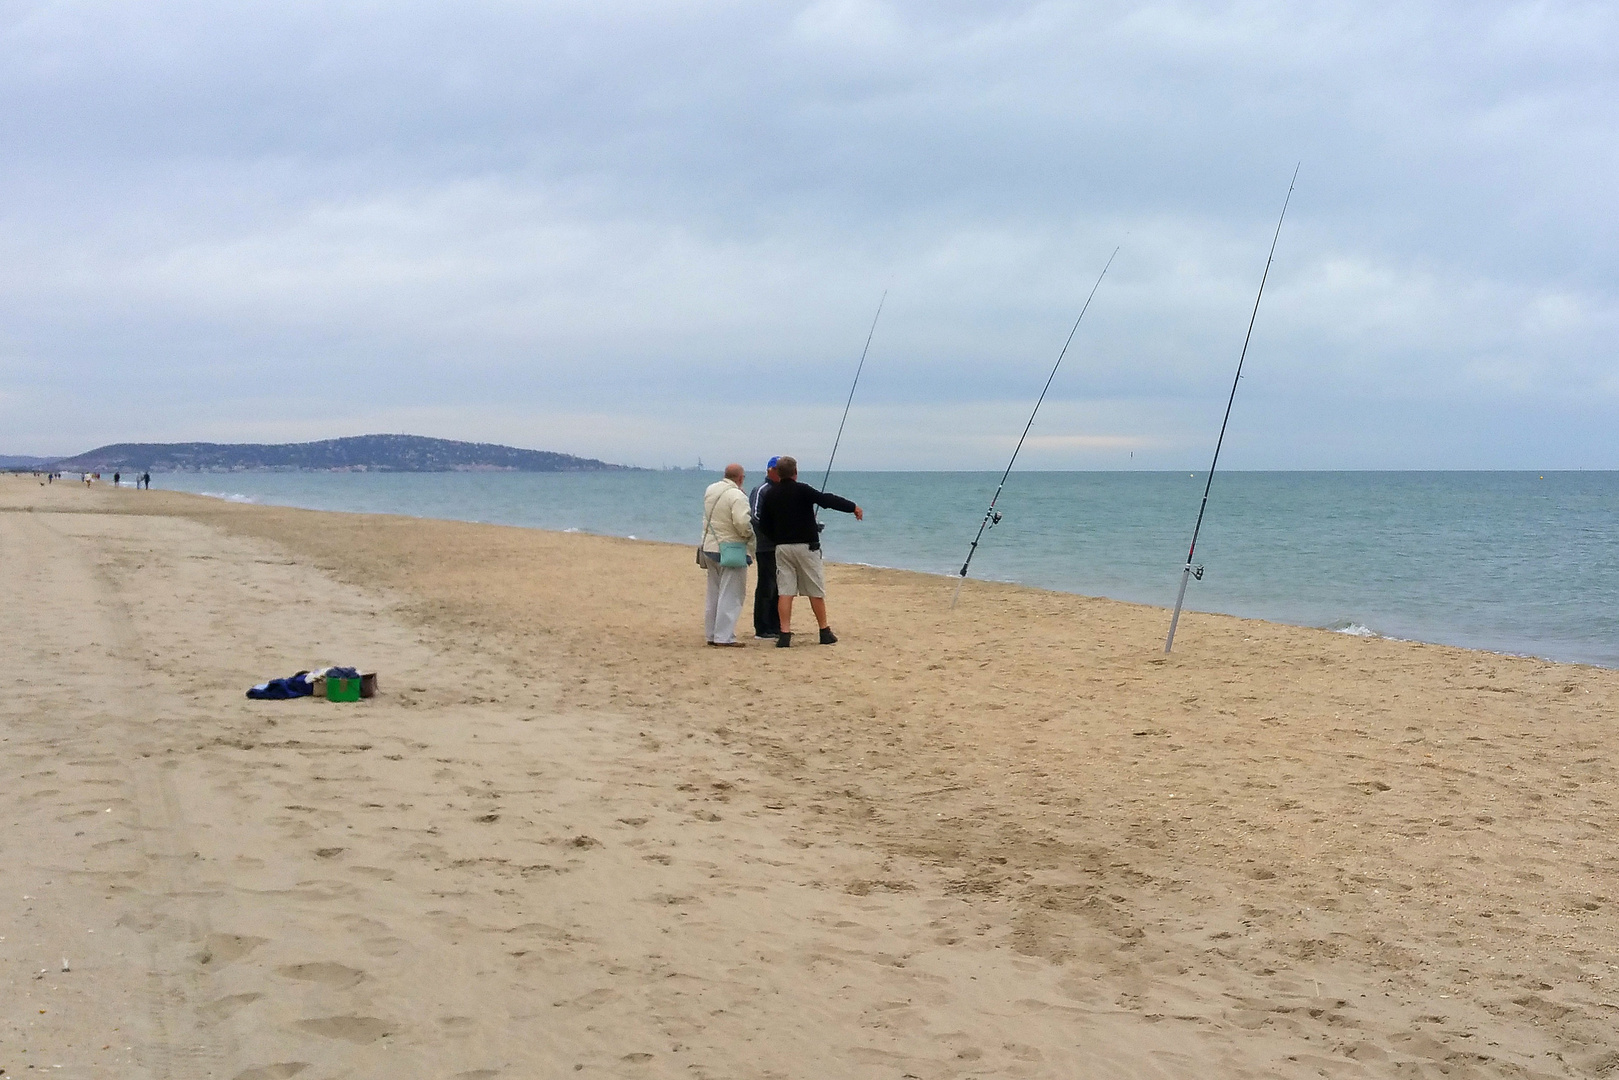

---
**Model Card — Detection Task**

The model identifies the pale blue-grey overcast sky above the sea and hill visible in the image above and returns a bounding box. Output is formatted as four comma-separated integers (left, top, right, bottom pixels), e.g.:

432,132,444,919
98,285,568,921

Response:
0,0,1619,468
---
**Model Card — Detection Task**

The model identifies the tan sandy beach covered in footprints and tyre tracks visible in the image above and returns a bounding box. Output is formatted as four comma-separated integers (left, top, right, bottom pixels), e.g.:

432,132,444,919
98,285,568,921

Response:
0,476,1619,1080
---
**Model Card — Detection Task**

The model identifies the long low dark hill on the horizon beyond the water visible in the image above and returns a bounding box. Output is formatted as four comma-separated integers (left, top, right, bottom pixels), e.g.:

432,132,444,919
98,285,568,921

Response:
52,436,627,473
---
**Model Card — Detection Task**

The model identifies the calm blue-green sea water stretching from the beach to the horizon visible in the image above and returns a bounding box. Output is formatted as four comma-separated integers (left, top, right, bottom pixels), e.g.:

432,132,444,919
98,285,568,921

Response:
152,471,1619,667
